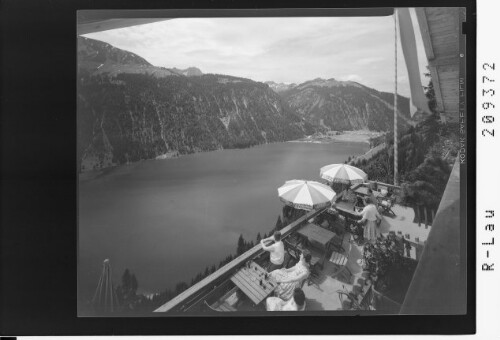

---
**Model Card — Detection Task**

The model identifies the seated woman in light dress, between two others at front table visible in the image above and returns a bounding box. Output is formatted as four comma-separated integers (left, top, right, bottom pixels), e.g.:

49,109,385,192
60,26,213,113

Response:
270,250,311,301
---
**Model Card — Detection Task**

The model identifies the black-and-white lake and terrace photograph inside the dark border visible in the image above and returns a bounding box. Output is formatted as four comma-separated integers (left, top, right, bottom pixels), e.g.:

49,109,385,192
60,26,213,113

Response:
75,7,467,317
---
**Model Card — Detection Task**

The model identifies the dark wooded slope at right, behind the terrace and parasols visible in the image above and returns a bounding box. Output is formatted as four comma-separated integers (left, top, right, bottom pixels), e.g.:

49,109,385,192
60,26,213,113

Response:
351,114,459,210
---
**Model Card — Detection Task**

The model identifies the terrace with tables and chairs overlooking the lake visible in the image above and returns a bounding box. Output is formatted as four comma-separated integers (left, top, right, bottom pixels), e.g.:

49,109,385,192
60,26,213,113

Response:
155,175,438,314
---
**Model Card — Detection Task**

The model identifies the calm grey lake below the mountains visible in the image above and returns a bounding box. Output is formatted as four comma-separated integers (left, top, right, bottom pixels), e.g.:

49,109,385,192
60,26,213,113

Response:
78,142,368,299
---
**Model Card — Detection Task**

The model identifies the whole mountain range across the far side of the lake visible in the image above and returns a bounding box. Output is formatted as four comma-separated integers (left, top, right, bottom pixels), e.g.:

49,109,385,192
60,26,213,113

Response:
77,37,412,171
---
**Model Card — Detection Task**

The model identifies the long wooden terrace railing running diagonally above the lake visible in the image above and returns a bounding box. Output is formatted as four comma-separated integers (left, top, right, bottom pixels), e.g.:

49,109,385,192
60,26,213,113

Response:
155,208,327,312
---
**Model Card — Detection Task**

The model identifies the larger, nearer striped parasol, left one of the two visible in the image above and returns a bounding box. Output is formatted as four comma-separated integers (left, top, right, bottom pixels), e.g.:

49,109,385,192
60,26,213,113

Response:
278,179,335,210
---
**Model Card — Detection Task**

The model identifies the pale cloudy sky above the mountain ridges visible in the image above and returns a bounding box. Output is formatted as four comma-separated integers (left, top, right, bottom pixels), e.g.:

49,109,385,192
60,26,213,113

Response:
85,10,428,96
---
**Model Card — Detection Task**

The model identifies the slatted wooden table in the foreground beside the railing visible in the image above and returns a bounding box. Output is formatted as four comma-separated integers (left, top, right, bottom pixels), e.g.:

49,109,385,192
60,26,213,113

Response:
231,262,278,305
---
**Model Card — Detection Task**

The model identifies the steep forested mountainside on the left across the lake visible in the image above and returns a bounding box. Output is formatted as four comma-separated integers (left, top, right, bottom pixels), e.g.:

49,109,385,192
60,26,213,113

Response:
77,39,314,171
